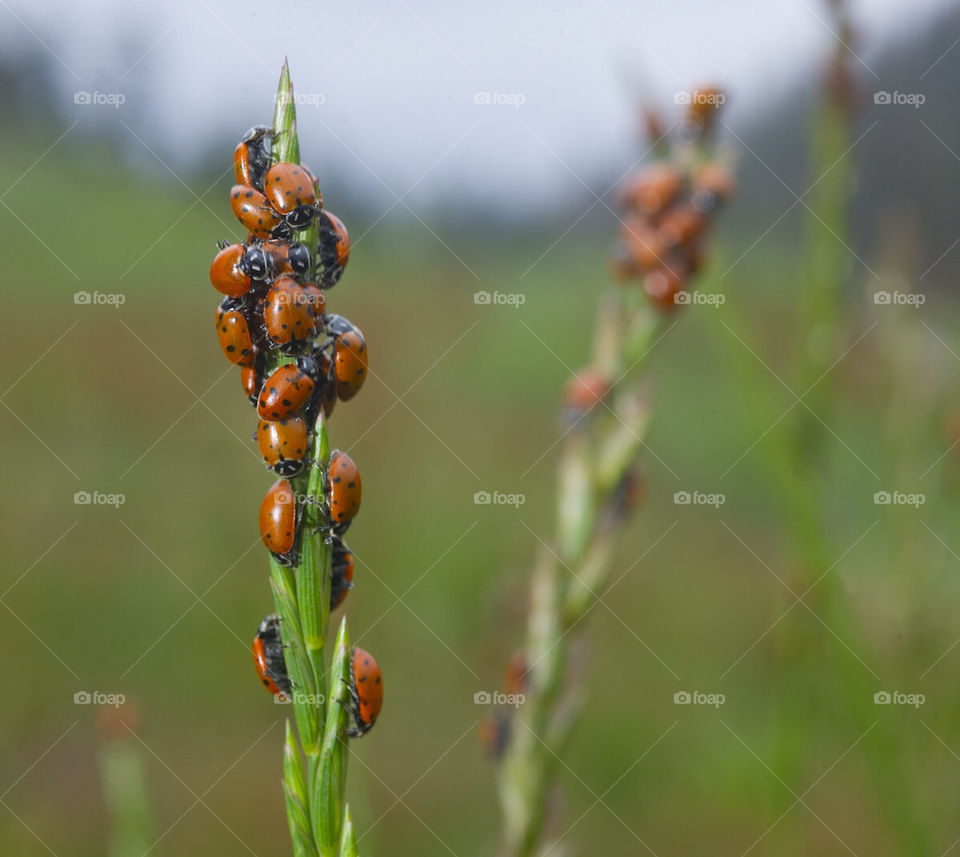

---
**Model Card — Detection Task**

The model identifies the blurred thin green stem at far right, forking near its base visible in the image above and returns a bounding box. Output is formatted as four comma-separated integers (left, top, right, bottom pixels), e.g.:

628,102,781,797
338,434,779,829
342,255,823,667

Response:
748,18,933,855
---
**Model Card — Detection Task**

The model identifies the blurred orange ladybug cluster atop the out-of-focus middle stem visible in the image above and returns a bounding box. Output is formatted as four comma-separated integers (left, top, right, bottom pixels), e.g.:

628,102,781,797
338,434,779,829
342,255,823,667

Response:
612,87,736,310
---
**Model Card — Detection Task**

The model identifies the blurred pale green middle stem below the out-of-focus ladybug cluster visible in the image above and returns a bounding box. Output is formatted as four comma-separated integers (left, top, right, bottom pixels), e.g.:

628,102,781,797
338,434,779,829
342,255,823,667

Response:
499,289,669,857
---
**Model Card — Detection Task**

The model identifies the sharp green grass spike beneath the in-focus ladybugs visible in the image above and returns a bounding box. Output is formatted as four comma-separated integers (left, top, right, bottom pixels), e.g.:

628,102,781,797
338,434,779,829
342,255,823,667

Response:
265,62,357,857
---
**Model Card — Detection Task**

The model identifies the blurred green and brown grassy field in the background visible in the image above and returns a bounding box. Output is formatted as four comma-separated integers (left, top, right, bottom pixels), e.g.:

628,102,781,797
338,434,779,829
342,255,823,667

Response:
0,137,960,857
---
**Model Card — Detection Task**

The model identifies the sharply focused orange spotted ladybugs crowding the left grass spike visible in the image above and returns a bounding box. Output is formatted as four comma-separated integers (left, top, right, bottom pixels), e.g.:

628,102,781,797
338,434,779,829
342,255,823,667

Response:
210,126,383,736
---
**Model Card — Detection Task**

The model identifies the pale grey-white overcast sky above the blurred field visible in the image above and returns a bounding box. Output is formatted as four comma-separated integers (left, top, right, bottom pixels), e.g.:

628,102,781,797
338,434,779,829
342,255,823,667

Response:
0,0,953,207
